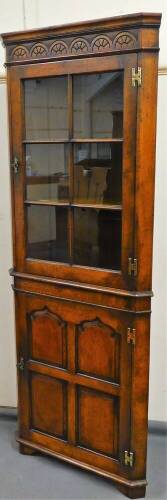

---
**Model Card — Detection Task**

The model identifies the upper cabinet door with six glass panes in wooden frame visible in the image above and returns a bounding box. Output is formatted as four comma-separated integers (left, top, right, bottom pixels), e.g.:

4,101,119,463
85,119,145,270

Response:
11,54,137,288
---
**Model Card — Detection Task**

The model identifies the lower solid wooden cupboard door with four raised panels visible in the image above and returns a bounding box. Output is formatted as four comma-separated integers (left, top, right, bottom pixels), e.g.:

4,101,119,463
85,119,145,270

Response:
16,293,132,475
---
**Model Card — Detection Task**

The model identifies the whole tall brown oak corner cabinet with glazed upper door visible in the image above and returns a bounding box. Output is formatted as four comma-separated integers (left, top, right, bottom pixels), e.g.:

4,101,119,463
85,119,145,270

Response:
2,13,161,498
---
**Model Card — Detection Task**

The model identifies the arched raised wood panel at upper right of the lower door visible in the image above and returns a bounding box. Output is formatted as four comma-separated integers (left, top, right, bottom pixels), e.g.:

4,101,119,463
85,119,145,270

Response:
76,318,120,382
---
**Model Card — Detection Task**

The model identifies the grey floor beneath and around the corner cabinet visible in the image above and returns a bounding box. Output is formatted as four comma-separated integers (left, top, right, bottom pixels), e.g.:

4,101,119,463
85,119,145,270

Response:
0,412,167,500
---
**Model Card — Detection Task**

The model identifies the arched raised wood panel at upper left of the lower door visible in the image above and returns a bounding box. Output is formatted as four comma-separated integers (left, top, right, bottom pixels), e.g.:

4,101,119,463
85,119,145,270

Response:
28,307,67,368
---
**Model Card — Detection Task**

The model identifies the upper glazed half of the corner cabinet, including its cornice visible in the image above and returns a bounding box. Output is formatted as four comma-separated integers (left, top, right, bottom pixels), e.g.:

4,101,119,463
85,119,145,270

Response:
2,14,161,290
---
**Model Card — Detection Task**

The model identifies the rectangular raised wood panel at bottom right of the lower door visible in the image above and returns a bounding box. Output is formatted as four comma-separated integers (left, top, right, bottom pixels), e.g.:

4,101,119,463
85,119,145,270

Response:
78,387,118,457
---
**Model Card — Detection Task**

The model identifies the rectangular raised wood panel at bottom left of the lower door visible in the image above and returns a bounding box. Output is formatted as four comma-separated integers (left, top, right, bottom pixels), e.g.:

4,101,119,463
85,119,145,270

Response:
30,373,67,439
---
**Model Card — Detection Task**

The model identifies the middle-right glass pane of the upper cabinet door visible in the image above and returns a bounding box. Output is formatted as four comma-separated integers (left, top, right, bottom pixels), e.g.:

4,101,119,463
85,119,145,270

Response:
74,143,122,204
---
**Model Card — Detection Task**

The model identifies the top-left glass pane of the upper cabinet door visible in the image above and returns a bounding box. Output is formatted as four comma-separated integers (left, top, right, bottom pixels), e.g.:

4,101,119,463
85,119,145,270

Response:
24,76,68,140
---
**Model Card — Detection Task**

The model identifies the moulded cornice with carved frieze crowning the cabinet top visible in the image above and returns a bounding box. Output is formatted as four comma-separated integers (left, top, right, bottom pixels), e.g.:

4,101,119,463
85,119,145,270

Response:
2,13,161,65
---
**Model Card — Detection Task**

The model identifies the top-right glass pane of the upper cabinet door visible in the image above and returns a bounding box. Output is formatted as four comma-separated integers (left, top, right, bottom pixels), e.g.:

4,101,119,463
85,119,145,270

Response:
73,71,123,138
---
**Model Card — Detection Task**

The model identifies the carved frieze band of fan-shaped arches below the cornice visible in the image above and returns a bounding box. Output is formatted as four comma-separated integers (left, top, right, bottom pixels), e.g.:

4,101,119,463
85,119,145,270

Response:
7,30,138,64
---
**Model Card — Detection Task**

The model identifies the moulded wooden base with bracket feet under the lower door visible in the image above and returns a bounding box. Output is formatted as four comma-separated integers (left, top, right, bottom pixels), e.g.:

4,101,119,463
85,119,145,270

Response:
16,437,147,498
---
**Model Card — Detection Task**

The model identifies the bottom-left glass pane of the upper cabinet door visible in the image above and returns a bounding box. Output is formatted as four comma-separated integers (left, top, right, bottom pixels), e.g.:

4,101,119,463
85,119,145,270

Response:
27,205,68,262
